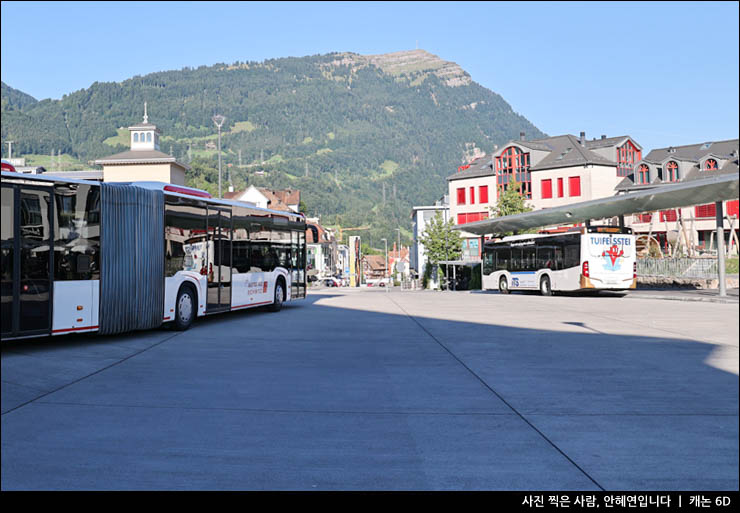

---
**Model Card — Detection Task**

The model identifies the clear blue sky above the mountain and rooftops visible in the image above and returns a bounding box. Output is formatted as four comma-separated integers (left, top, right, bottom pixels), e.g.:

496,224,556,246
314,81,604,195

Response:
1,1,739,150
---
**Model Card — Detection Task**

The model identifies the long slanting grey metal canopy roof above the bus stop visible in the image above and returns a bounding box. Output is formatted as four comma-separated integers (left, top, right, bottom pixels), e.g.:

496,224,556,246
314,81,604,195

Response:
454,174,738,235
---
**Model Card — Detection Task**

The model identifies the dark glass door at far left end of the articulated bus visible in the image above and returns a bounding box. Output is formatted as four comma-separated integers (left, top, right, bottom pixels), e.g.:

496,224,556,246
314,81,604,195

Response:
0,185,53,338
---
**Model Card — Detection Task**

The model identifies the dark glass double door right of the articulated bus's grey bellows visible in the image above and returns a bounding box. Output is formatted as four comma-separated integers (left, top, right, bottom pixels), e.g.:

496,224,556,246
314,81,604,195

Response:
206,206,231,313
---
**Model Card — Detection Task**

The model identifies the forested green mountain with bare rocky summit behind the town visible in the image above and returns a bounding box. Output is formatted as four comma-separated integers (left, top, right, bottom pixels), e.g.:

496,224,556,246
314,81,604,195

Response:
2,50,544,247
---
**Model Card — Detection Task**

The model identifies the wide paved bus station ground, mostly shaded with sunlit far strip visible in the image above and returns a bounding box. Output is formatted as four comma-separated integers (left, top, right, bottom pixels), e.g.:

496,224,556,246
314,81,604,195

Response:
0,288,738,490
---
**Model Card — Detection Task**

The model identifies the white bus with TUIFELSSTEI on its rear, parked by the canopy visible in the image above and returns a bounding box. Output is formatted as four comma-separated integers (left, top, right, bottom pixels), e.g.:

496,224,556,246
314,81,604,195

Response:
481,226,637,296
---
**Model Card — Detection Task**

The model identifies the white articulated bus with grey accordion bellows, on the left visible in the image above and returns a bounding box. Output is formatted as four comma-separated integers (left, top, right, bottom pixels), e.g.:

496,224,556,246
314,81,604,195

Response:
0,171,306,340
